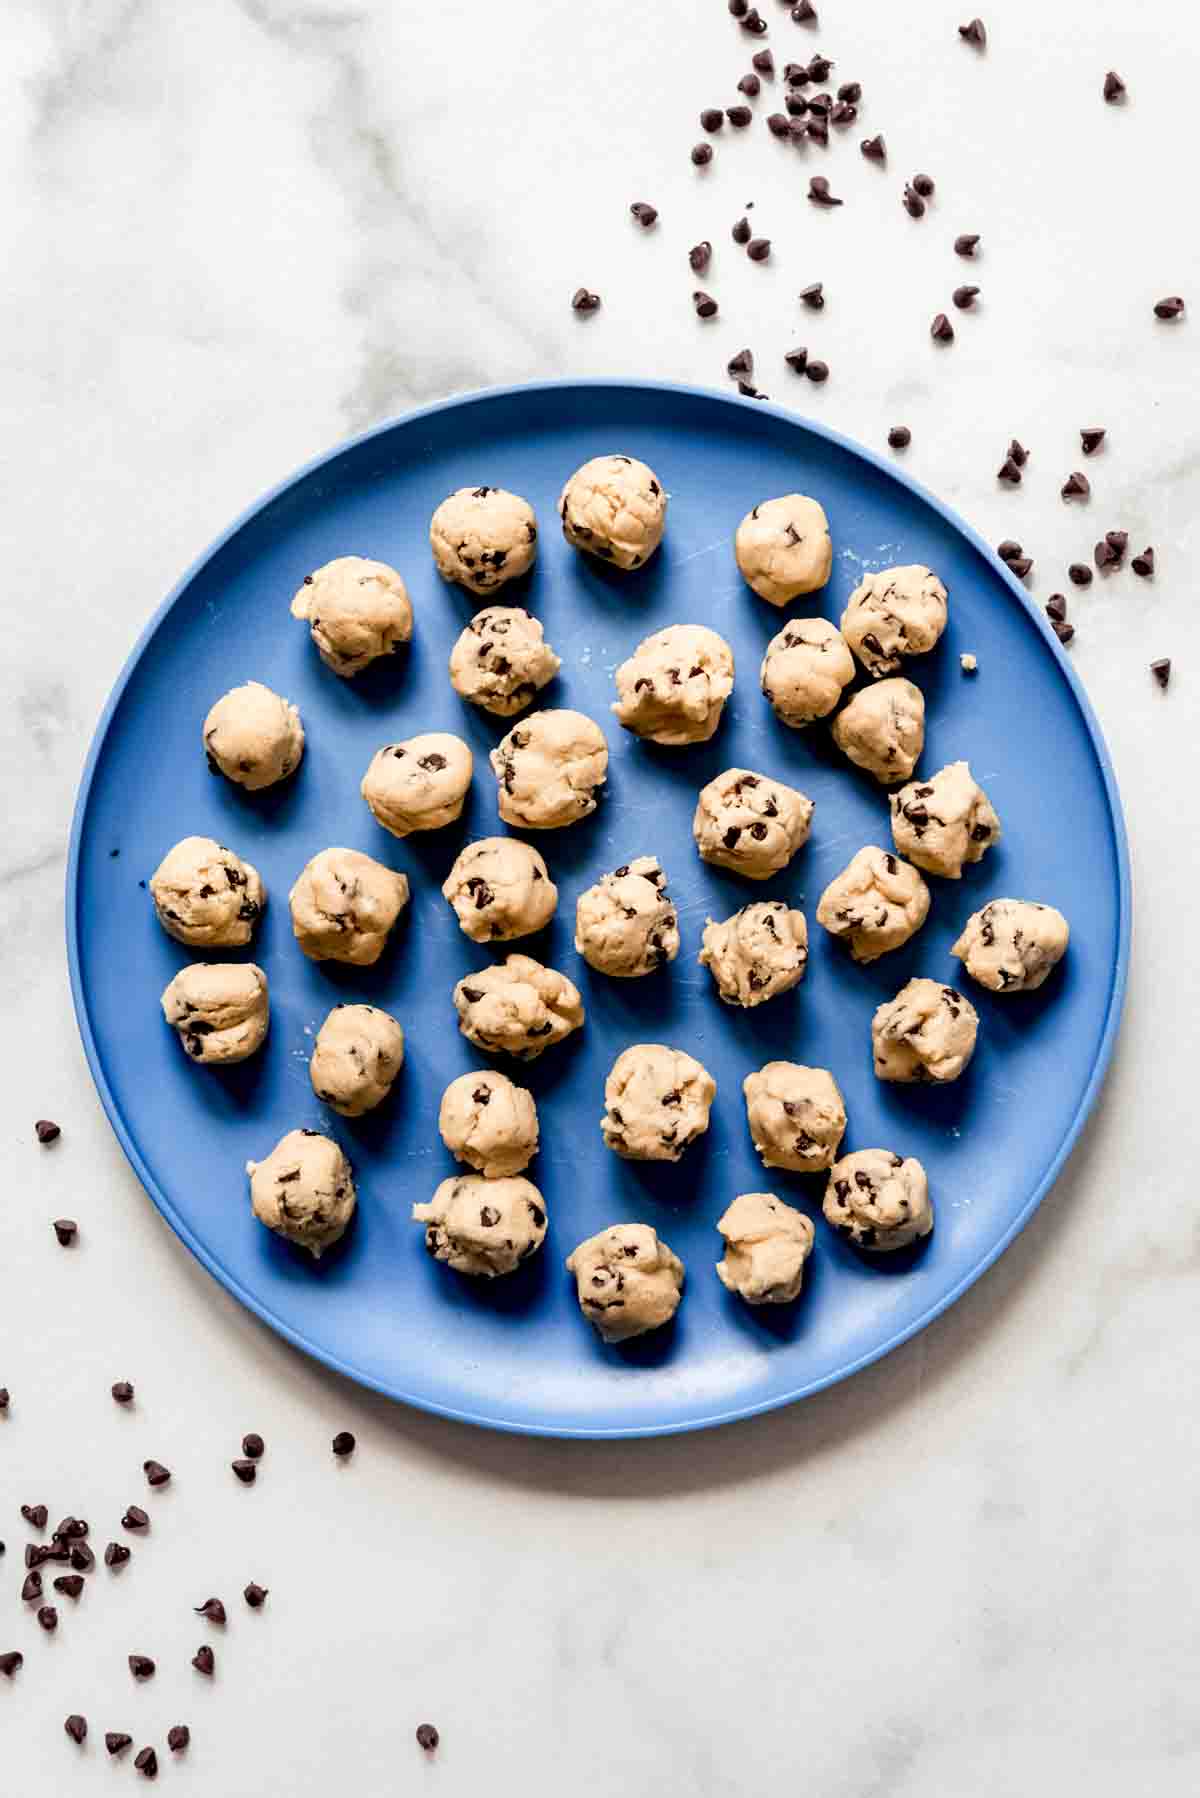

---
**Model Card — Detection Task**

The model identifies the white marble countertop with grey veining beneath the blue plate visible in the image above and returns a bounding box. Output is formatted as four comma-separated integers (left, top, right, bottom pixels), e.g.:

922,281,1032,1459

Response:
0,0,1200,1798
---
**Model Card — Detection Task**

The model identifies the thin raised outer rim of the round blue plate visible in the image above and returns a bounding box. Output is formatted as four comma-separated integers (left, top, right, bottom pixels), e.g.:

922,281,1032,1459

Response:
63,376,1133,1442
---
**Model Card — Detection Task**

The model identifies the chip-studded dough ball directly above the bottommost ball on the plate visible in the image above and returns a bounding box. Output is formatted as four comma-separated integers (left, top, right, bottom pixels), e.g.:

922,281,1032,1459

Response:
601,1043,716,1162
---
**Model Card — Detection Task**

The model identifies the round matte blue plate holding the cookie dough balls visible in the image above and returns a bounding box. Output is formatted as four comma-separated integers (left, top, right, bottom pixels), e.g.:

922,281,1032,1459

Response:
67,381,1130,1437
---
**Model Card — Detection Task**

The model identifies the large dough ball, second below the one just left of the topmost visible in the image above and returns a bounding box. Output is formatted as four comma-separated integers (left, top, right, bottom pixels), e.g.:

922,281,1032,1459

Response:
491,712,608,831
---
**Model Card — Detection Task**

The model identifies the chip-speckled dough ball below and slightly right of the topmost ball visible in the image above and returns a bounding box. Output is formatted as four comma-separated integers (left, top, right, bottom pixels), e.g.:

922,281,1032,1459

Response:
613,624,734,746
